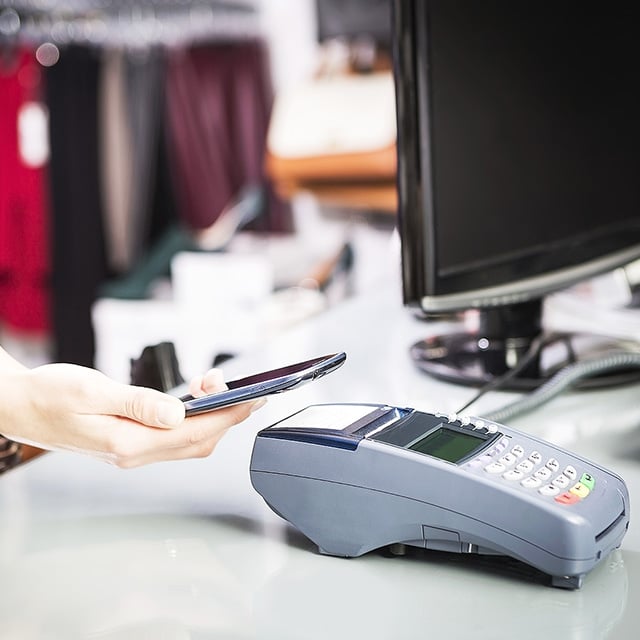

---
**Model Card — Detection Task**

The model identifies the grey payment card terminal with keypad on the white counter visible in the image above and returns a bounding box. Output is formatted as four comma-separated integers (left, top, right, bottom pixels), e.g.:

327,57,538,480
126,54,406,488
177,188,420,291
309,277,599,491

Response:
250,404,629,589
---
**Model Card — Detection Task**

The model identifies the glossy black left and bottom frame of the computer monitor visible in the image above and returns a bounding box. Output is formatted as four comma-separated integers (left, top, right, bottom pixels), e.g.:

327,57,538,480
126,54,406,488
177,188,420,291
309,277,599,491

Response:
392,0,640,313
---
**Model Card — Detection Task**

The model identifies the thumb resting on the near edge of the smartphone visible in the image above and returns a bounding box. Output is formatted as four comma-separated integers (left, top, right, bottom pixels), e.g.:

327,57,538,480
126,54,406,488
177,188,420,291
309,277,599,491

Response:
116,385,185,429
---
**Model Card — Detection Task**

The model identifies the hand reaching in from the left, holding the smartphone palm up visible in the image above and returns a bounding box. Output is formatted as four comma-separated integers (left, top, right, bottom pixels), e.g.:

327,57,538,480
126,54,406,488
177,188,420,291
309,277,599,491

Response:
0,364,265,468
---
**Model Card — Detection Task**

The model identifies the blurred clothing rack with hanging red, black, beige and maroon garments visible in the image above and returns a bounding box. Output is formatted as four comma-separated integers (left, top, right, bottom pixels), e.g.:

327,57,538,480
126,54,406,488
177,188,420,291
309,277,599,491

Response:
0,0,291,366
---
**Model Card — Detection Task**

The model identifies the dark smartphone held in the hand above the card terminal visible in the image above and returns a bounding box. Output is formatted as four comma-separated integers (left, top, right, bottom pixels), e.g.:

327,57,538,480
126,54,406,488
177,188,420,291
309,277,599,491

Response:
182,352,347,416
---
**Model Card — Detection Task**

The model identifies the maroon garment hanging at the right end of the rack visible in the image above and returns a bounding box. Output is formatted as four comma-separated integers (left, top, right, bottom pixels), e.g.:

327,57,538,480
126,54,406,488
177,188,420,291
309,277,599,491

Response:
166,41,292,232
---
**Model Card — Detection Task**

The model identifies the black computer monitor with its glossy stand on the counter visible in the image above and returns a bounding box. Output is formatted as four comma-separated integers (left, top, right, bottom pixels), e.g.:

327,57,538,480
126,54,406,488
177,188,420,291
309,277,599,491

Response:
392,0,640,388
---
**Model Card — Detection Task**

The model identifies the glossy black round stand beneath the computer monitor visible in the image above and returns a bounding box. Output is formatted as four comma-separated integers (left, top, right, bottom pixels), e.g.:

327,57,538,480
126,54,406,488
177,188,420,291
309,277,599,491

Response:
410,299,640,391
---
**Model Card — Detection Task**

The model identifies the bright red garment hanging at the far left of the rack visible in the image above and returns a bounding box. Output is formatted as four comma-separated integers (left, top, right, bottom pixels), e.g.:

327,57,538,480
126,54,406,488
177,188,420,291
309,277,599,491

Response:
0,49,50,333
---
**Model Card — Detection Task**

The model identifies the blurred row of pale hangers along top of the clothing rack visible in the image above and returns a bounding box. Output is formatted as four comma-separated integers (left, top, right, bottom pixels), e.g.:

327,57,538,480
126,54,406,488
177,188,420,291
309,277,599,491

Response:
0,0,260,48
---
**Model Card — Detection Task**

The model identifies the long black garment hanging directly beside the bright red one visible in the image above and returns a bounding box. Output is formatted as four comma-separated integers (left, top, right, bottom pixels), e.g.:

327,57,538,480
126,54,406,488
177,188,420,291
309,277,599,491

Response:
46,45,107,366
